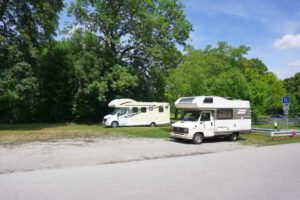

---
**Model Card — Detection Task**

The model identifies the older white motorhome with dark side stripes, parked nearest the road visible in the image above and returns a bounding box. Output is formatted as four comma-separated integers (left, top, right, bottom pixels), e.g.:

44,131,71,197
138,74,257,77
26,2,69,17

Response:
170,96,251,144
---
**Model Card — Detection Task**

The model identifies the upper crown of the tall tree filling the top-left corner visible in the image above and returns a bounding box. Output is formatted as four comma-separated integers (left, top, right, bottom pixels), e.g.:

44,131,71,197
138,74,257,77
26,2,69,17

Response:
0,0,63,70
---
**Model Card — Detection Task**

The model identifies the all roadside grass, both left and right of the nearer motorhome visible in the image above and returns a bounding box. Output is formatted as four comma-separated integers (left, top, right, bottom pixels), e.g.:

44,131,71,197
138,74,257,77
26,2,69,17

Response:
0,123,300,146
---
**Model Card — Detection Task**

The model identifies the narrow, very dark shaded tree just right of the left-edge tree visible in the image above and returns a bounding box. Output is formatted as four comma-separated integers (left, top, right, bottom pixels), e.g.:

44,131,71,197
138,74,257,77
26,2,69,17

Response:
37,41,76,121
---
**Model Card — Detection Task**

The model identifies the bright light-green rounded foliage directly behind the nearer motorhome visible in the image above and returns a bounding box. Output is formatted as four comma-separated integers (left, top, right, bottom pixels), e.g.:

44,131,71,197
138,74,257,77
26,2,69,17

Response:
167,42,284,115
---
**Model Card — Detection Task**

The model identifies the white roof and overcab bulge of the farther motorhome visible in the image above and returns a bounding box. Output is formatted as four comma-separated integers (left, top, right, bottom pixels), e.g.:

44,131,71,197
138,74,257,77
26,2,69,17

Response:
108,99,169,108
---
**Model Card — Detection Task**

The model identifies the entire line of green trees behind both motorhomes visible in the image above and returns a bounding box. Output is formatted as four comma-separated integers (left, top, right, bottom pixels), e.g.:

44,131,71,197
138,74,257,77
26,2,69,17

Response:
0,0,300,122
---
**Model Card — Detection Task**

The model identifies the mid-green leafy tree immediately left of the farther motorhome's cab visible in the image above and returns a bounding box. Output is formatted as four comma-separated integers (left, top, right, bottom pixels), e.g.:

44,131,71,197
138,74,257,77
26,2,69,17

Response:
55,30,137,121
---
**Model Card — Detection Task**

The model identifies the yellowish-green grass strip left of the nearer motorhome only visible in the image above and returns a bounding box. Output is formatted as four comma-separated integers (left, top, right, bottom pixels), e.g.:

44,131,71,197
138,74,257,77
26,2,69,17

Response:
0,123,170,143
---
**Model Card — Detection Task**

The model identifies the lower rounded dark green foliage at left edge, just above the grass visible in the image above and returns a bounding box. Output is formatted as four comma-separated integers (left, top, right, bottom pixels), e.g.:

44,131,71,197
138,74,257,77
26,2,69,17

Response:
0,62,38,122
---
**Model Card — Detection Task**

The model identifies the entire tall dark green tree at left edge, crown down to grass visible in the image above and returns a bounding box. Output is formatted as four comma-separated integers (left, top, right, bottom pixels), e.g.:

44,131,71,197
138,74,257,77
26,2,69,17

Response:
0,0,63,121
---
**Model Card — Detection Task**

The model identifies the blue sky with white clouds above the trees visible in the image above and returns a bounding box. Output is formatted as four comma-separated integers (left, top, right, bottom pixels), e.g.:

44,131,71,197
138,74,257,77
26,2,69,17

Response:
60,0,300,79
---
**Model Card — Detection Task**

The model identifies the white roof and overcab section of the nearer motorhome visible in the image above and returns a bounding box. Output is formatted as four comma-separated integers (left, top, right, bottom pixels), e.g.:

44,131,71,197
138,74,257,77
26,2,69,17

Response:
175,96,250,110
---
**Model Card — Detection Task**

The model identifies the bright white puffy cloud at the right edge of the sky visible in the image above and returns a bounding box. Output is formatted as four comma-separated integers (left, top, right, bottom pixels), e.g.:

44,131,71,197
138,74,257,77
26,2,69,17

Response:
273,34,300,49
